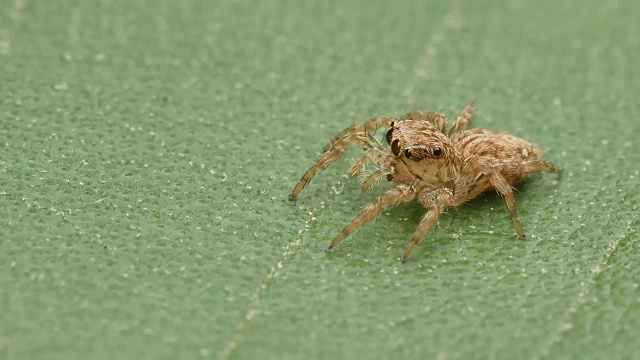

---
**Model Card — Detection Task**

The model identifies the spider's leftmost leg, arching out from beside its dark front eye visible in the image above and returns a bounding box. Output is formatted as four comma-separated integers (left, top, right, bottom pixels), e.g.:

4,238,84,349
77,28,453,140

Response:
289,117,392,200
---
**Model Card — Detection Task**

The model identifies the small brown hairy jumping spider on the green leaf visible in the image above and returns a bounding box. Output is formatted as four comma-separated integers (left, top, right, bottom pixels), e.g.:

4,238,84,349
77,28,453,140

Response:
289,105,561,262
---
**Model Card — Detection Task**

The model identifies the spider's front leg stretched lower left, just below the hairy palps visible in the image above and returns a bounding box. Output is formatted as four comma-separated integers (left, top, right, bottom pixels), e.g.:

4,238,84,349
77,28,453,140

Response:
329,184,416,249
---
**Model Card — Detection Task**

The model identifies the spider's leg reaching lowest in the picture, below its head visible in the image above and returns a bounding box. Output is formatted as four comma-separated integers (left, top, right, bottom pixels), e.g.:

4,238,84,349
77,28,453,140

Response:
402,188,454,262
